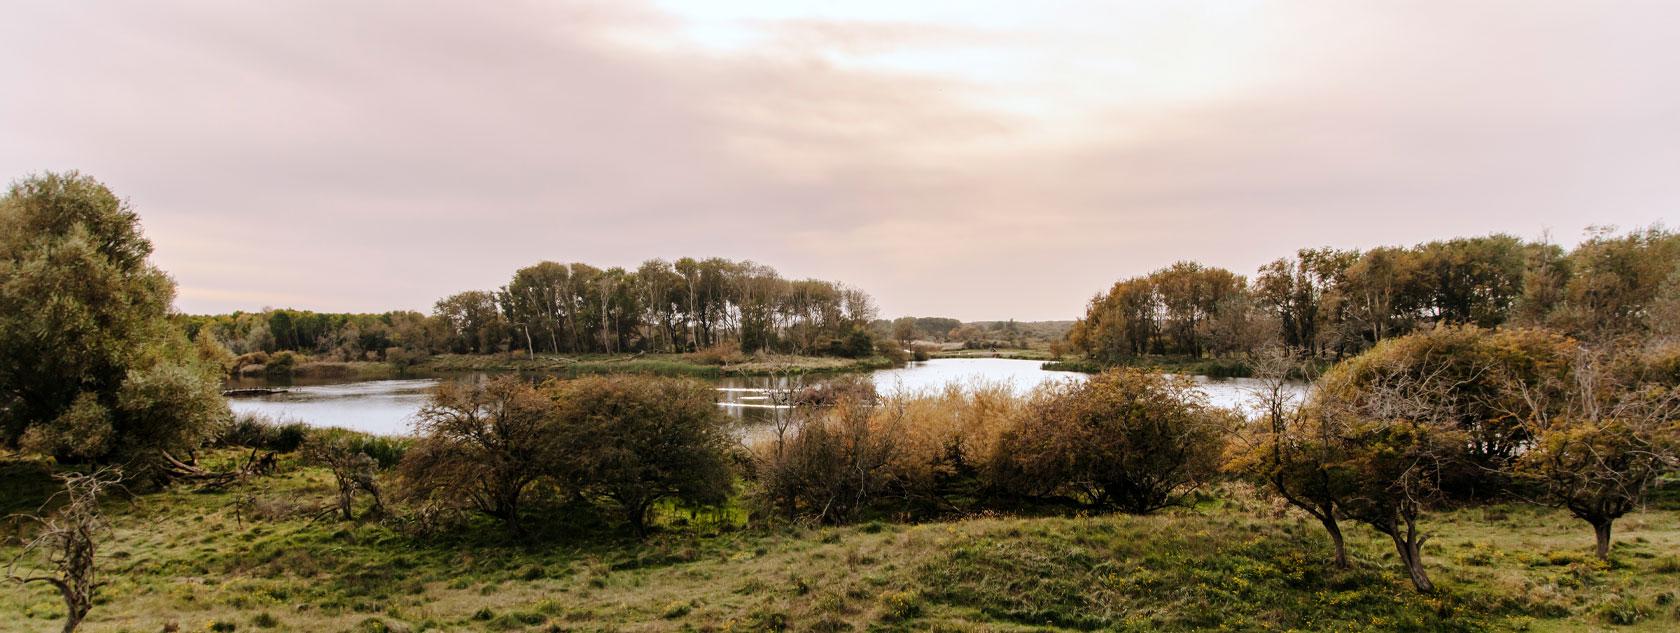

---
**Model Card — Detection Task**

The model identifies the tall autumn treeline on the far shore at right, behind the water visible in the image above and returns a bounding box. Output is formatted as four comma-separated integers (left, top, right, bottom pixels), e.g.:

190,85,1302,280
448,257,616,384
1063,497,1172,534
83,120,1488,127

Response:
1068,228,1680,361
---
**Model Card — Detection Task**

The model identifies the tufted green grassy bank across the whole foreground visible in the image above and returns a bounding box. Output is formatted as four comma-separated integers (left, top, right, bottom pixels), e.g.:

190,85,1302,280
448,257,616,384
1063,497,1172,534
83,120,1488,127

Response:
0,449,1680,631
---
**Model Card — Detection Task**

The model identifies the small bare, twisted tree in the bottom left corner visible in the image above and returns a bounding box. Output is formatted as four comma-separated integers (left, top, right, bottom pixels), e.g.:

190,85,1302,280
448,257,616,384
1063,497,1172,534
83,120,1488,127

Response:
7,468,121,633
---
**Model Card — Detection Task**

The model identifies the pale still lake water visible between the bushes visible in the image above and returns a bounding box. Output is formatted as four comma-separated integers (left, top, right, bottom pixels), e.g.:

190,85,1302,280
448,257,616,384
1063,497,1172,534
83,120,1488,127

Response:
228,358,1305,435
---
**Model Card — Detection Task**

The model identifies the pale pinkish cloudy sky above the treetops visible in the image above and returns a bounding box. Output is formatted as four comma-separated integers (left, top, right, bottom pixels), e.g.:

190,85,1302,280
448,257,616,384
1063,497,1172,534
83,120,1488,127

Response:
0,0,1680,315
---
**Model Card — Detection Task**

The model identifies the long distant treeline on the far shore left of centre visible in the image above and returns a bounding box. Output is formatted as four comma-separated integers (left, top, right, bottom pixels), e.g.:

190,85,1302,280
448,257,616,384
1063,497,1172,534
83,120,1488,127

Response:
181,257,875,361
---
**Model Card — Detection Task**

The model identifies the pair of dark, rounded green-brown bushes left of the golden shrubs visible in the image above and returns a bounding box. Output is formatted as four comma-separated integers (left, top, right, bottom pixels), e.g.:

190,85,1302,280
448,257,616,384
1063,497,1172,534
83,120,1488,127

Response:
398,376,732,534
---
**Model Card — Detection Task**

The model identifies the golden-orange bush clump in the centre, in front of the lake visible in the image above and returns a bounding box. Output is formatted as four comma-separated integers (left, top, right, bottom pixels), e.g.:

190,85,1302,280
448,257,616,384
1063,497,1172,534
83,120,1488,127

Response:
748,368,1235,522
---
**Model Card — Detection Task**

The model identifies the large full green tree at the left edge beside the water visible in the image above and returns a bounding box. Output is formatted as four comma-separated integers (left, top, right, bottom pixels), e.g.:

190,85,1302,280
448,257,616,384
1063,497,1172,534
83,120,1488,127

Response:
0,173,227,470
